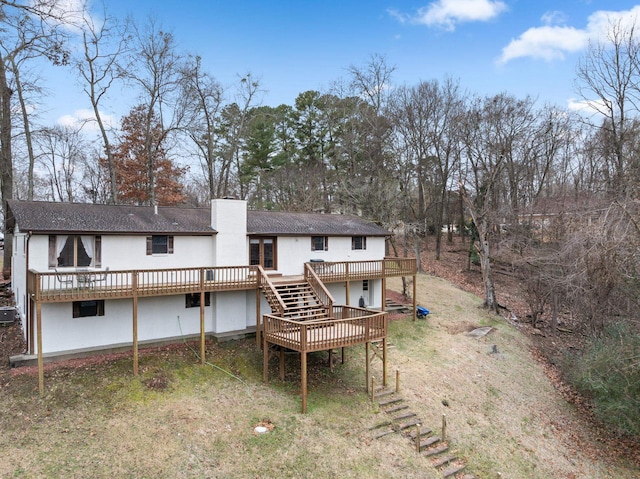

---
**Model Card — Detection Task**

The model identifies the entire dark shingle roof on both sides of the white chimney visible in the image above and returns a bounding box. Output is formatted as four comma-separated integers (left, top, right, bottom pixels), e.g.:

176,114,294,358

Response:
7,200,390,236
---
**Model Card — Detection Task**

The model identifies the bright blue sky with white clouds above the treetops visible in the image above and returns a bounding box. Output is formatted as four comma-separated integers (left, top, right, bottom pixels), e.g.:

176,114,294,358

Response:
52,0,640,128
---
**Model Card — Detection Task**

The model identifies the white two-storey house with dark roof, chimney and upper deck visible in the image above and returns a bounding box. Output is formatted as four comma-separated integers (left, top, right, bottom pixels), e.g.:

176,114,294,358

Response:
7,199,416,412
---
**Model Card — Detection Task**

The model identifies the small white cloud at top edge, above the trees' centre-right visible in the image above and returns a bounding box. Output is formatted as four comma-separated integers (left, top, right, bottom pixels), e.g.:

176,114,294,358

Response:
400,0,507,31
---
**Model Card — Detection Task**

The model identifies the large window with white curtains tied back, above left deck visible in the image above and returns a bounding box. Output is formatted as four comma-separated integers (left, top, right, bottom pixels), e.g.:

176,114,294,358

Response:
49,235,102,268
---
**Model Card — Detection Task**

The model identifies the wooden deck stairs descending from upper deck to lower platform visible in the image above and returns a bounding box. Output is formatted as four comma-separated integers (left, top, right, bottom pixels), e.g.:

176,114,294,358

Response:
263,276,331,321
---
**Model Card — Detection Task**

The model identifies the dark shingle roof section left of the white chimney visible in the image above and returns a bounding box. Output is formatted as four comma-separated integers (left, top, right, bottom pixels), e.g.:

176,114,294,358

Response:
7,200,215,235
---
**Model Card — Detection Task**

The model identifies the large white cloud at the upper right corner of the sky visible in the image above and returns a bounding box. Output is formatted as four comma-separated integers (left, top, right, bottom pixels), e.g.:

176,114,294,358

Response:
498,5,640,63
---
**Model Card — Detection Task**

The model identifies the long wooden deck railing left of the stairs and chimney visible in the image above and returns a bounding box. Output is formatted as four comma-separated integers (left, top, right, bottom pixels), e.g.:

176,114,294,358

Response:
27,266,258,302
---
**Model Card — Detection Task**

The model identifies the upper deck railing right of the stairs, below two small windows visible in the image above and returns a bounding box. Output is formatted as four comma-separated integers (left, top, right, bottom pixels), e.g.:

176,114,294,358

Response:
306,257,417,283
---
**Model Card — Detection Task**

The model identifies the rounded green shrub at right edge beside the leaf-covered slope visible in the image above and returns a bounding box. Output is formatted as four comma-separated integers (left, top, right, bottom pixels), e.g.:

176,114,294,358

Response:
567,322,640,436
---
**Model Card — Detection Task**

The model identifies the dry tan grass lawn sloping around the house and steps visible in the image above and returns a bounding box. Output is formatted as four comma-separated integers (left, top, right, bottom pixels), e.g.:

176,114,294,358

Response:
0,276,639,479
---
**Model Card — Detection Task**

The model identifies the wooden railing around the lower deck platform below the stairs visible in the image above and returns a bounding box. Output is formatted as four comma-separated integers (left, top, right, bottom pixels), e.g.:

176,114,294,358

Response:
263,306,387,352
